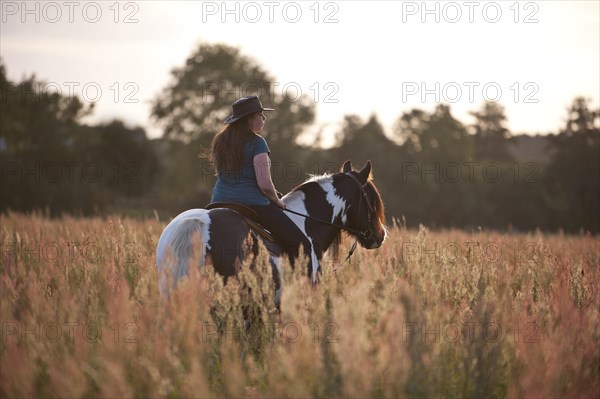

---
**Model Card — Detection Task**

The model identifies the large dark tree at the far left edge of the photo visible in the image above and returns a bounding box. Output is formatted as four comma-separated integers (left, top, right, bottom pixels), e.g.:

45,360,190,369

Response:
0,64,93,214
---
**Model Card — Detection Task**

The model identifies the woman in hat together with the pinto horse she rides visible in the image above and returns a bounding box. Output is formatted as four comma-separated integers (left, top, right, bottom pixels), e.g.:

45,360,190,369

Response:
156,96,387,301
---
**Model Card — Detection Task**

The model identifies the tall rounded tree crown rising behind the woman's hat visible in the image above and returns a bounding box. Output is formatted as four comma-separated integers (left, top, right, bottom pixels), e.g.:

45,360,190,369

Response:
152,44,314,144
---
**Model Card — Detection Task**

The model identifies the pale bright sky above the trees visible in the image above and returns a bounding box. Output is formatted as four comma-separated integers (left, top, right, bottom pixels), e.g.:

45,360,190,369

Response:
0,0,600,144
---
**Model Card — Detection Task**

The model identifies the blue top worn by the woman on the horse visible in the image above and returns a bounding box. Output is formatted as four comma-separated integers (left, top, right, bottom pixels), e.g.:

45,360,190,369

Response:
210,136,271,205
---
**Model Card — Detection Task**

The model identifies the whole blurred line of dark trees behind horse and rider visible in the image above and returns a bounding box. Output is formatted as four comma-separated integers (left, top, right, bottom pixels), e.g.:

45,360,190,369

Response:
0,44,600,233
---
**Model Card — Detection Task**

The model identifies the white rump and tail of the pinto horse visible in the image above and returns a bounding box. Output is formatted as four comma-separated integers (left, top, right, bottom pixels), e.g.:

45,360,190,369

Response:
156,209,210,295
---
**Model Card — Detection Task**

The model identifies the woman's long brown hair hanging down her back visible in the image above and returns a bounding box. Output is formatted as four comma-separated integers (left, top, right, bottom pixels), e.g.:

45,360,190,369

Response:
210,114,254,174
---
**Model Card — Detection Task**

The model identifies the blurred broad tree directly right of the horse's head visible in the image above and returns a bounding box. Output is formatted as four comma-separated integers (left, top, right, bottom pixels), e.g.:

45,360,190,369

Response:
394,104,474,227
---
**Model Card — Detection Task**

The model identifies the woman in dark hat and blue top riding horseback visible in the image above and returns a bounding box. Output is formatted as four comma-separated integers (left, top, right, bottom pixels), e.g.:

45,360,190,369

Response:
210,96,312,271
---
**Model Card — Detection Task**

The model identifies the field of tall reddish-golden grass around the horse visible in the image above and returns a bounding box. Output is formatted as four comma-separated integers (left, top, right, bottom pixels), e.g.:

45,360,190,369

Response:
0,214,600,398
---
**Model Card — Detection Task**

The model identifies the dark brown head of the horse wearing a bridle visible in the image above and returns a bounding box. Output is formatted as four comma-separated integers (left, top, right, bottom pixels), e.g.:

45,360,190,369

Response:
336,161,387,249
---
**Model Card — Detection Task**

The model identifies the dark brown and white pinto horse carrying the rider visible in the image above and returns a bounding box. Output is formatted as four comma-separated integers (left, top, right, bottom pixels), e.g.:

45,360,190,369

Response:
156,161,387,303
